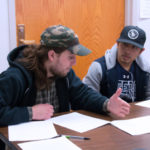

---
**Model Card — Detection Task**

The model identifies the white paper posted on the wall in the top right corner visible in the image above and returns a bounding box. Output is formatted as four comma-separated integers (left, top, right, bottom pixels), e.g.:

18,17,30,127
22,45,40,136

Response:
140,0,150,18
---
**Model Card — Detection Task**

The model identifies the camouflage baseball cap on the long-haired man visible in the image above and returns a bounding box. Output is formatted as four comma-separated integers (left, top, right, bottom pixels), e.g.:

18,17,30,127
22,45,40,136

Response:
40,25,91,56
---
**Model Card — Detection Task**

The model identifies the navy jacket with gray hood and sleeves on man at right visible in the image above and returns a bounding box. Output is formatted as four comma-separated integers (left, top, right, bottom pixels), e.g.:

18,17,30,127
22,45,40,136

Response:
83,44,150,100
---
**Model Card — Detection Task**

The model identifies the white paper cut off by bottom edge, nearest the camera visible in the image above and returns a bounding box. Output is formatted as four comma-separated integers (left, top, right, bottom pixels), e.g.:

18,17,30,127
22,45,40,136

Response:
18,137,81,150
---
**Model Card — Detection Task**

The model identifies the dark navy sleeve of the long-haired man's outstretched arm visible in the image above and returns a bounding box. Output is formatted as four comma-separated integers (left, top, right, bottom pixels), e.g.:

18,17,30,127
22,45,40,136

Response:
68,70,108,113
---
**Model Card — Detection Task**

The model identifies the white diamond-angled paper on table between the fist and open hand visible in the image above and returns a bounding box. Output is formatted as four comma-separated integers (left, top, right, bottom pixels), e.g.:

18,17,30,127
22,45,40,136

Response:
50,112,109,133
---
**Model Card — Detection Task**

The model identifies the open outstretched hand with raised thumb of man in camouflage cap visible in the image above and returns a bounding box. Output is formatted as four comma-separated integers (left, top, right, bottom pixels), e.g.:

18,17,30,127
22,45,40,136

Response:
107,88,130,118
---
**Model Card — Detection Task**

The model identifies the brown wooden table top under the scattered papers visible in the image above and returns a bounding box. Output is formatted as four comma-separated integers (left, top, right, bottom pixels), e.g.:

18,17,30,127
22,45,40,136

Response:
0,104,150,150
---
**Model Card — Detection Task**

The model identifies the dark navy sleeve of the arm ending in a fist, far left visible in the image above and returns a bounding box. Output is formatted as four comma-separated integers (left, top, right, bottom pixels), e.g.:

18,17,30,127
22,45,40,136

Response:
0,68,29,126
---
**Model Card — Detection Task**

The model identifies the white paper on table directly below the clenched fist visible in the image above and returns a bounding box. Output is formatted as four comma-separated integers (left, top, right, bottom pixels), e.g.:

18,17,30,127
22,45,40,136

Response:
8,120,57,141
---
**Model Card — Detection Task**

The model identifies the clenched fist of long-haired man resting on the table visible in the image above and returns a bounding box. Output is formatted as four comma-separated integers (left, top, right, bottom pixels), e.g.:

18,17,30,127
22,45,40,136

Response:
32,104,54,120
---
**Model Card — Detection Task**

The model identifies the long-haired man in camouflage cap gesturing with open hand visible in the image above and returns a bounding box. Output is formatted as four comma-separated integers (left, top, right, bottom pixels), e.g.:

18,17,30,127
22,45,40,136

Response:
0,25,130,126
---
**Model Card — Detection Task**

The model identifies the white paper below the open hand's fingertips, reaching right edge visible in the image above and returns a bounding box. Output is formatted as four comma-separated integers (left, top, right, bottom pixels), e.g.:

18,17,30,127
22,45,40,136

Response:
111,116,150,135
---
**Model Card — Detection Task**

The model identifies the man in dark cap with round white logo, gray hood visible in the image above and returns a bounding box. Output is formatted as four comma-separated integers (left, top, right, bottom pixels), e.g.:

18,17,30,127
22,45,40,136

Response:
83,26,150,103
